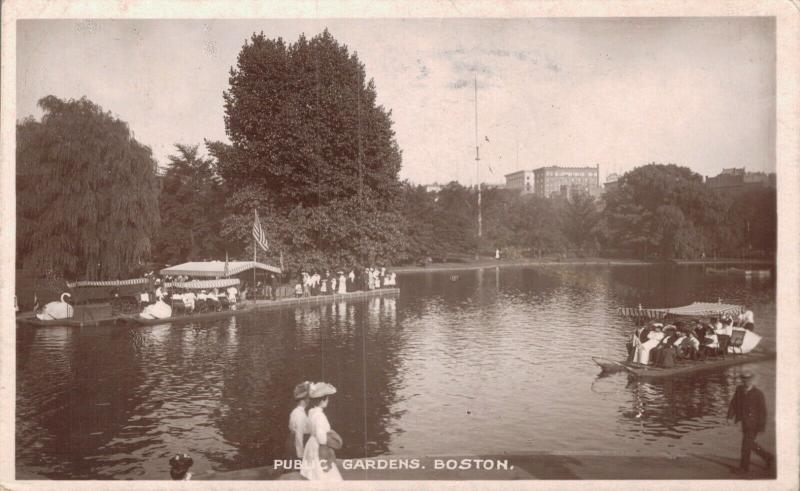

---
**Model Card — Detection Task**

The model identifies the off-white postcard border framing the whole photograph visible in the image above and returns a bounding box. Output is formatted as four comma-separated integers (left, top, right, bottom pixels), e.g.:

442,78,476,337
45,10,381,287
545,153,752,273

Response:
0,0,800,491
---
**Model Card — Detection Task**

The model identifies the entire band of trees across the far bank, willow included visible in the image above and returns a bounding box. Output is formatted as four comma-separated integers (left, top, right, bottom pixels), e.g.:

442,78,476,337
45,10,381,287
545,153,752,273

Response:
17,31,777,279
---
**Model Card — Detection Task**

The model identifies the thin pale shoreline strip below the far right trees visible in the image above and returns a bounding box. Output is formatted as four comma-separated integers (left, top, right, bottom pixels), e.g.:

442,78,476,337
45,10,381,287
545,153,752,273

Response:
390,257,775,273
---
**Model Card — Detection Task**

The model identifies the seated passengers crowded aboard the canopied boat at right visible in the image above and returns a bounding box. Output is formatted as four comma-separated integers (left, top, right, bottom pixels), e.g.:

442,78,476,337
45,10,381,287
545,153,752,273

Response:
627,310,755,368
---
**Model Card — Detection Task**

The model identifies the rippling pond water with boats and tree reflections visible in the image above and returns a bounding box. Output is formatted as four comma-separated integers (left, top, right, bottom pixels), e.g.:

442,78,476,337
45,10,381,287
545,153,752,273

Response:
16,265,775,479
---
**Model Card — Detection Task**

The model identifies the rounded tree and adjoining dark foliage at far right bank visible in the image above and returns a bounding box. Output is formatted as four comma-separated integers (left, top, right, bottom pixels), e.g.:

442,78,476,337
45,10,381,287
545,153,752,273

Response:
603,164,776,258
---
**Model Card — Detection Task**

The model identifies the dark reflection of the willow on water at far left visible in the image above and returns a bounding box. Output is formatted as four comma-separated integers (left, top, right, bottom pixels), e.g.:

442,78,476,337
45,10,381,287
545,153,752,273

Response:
17,328,157,479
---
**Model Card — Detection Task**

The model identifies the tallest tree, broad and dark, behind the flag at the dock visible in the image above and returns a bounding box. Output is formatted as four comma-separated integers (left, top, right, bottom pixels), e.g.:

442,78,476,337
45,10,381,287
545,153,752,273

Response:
208,30,403,267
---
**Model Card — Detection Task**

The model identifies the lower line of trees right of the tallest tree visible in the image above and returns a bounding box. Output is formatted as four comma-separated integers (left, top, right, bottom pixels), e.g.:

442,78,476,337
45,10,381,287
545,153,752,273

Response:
401,164,776,259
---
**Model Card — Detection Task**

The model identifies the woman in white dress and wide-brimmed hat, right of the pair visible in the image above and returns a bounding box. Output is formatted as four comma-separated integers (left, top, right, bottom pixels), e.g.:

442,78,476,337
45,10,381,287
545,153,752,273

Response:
300,382,342,481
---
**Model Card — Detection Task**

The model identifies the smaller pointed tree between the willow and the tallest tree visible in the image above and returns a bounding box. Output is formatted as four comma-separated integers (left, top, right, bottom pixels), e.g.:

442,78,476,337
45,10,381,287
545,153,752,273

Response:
153,144,226,264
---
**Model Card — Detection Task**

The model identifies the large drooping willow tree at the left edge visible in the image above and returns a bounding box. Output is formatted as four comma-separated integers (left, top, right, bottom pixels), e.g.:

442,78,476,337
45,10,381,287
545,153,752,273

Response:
17,96,159,278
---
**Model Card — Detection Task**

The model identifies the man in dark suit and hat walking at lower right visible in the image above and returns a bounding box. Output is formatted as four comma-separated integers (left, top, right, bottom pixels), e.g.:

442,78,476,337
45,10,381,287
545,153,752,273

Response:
728,370,775,473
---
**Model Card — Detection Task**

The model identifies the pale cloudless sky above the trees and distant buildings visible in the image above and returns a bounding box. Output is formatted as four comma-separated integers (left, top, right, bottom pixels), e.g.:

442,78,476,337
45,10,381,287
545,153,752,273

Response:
17,17,775,184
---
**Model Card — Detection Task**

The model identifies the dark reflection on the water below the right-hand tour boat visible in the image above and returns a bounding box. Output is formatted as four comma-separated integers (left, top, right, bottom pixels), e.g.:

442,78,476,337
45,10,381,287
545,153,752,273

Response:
618,372,736,438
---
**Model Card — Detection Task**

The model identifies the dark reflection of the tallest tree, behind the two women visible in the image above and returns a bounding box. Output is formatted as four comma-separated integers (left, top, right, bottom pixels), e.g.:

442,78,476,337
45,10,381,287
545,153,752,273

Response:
208,297,403,469
